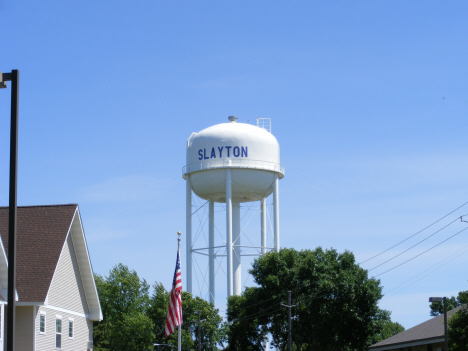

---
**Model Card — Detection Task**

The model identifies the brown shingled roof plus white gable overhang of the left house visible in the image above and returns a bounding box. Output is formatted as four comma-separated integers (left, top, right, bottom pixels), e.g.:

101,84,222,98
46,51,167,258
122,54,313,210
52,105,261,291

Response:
0,204,102,321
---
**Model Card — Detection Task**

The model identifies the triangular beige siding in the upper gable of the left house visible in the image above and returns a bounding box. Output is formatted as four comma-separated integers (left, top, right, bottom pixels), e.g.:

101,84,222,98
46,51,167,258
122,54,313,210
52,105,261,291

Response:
47,235,89,314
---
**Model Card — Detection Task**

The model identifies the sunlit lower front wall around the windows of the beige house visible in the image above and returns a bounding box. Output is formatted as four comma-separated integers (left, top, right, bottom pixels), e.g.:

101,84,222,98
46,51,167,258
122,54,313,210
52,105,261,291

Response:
34,306,92,351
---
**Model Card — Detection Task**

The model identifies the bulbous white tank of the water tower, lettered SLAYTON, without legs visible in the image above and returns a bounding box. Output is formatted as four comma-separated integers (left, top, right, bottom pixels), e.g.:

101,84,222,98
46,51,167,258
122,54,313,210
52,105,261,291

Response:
183,116,284,202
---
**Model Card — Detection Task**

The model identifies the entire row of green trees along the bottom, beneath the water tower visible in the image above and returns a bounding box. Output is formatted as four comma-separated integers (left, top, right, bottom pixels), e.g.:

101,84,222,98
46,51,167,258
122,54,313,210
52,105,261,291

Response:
94,254,403,351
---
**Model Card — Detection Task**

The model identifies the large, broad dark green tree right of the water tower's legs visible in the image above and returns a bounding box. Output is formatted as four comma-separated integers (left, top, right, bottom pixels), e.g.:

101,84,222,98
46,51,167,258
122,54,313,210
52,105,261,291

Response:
227,248,388,351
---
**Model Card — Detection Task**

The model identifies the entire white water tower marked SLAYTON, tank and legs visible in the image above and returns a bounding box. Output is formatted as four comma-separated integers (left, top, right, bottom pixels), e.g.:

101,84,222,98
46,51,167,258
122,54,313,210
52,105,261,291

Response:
182,116,284,302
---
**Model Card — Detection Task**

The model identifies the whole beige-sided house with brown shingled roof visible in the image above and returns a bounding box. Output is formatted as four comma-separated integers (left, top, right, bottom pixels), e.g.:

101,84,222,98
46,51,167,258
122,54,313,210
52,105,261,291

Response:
0,204,102,351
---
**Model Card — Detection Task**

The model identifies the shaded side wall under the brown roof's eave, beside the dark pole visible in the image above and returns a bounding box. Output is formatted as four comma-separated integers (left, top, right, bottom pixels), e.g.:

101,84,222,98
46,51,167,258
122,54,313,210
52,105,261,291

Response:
15,306,35,351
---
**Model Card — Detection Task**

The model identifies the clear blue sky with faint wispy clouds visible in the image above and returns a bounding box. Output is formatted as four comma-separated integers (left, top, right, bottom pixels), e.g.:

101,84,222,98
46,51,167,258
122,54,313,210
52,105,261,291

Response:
0,0,468,328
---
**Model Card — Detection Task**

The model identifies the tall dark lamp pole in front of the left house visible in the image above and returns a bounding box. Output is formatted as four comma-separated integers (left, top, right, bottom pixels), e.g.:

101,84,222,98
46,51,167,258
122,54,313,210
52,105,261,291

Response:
0,70,19,351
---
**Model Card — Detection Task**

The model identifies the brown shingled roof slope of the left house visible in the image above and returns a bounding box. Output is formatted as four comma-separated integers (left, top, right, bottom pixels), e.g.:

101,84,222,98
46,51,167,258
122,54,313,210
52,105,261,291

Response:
0,204,78,302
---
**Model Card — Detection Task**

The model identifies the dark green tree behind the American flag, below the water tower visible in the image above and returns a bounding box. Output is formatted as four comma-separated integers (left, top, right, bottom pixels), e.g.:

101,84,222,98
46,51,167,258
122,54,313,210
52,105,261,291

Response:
148,283,227,351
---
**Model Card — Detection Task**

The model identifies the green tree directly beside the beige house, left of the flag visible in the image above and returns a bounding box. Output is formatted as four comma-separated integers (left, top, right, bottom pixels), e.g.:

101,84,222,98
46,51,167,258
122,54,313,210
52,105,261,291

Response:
93,263,154,351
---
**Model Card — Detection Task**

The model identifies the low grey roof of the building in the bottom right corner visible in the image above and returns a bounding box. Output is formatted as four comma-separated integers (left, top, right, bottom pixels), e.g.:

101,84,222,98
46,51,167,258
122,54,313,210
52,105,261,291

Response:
369,306,462,351
